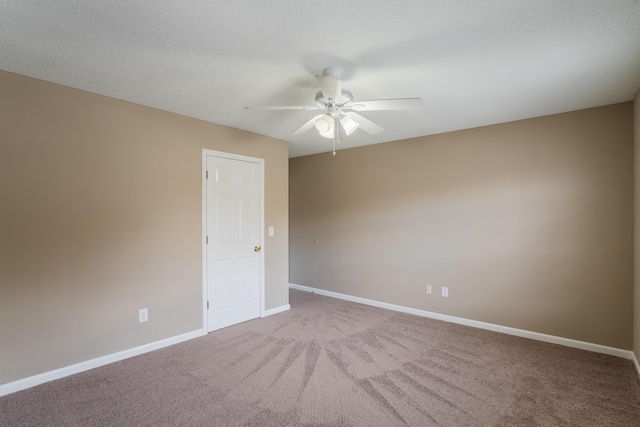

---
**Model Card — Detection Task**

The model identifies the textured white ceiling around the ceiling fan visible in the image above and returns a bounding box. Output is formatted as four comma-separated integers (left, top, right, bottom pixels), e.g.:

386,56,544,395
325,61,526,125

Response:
0,0,640,157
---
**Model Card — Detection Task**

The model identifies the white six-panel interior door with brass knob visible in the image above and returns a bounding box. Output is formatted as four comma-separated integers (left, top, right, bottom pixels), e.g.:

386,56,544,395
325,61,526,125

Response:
205,155,262,331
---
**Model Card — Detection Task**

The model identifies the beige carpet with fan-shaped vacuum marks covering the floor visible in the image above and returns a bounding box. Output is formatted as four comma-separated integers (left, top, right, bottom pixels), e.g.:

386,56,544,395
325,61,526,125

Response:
0,290,640,427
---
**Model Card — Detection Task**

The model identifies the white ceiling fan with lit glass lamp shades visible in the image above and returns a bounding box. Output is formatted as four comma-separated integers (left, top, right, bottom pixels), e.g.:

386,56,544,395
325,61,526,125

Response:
245,67,425,156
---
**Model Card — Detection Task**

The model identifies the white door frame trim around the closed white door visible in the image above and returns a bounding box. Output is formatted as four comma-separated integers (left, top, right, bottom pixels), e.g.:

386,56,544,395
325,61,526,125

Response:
202,148,266,333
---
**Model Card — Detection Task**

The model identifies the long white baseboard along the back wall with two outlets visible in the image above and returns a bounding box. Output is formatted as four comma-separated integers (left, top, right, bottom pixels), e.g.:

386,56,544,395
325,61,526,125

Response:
289,283,640,364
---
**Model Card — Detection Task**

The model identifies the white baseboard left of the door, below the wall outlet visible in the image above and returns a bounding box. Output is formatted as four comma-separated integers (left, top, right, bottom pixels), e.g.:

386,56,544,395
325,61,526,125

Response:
0,329,206,397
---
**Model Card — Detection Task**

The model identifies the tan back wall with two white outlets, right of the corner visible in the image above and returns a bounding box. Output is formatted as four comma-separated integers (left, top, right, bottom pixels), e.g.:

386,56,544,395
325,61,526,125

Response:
289,102,633,349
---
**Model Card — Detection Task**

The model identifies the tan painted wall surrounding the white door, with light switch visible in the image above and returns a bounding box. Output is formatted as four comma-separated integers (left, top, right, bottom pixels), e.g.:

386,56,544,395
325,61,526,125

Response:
0,72,289,384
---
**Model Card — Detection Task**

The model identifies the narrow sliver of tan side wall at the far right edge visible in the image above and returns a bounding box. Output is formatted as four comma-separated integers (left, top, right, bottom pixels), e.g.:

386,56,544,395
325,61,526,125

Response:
633,91,640,360
